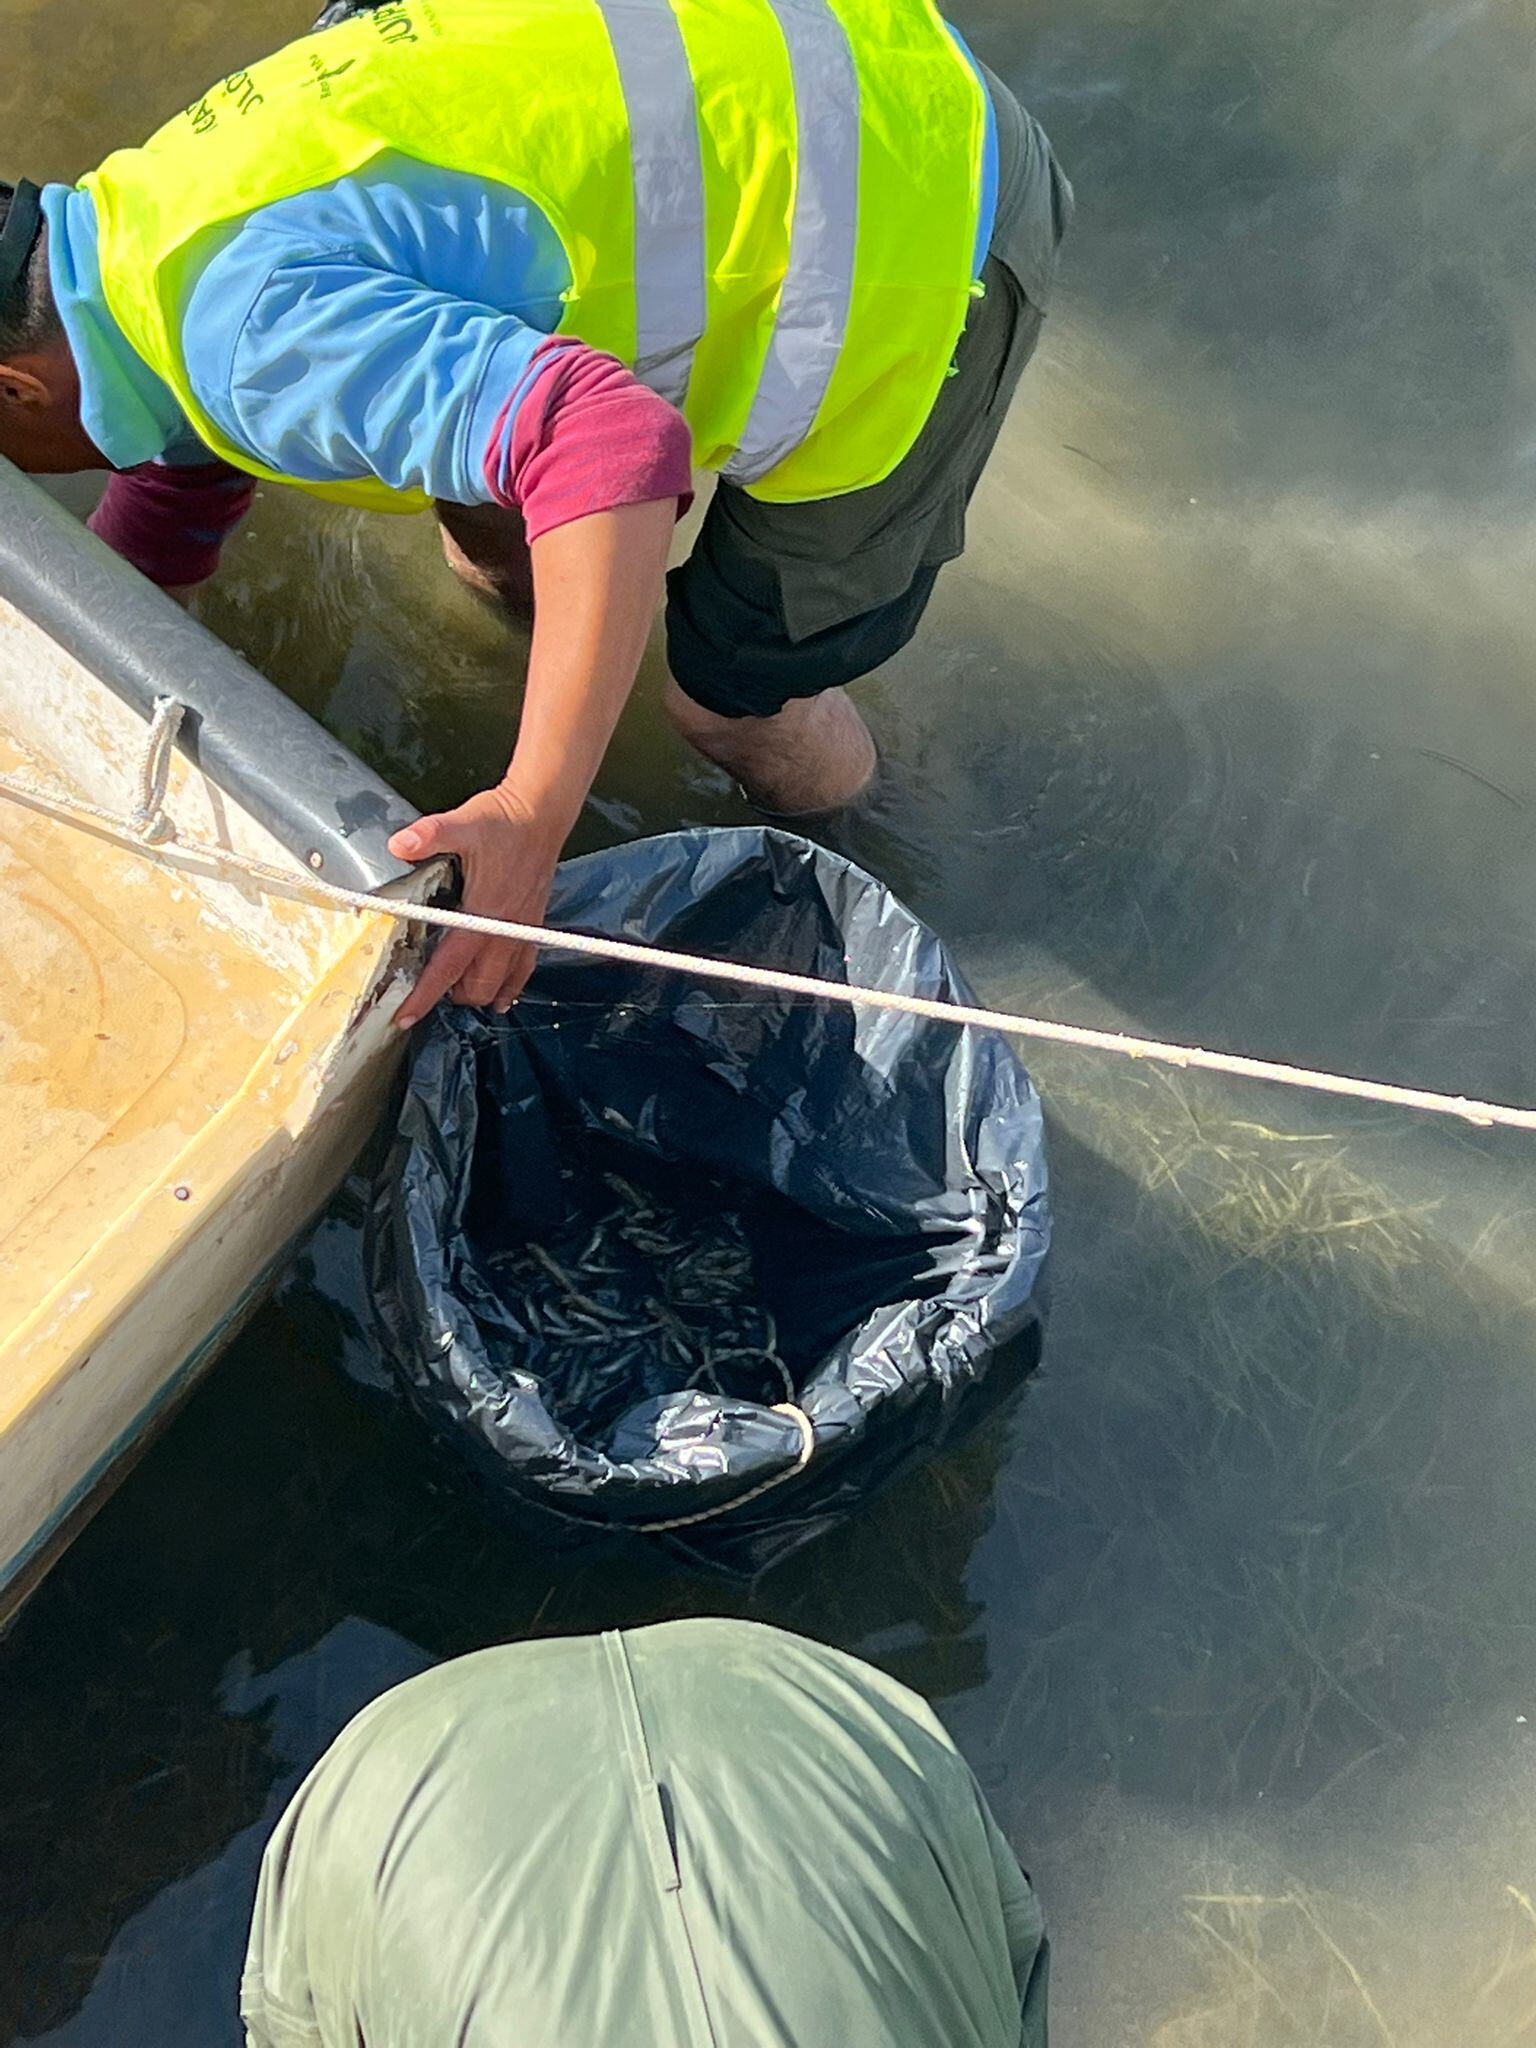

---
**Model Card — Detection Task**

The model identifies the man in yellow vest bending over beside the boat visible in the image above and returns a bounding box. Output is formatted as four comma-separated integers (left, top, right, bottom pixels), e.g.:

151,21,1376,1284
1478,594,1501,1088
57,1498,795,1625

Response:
0,0,1071,1024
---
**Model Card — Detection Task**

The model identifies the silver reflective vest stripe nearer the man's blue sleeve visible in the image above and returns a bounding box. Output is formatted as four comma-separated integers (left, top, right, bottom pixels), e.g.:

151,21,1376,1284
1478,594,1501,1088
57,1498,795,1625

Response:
598,0,709,406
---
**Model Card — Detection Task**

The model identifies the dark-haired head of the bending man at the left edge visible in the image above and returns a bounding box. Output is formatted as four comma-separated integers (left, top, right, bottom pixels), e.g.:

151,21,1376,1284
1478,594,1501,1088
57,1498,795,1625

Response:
0,180,102,475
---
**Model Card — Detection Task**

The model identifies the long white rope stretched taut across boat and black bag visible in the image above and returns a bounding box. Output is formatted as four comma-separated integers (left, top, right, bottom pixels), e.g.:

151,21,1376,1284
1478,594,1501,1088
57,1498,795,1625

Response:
0,753,1536,1130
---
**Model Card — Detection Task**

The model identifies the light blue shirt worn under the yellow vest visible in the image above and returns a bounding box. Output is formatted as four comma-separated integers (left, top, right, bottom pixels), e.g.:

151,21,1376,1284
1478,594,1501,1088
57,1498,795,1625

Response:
43,37,997,504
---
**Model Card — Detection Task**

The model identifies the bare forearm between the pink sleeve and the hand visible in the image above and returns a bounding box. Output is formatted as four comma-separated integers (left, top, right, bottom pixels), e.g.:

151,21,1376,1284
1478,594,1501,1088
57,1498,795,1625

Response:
502,498,678,850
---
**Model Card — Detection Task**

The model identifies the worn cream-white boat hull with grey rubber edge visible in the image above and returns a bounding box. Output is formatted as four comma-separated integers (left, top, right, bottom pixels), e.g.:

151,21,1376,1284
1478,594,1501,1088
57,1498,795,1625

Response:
0,465,440,1624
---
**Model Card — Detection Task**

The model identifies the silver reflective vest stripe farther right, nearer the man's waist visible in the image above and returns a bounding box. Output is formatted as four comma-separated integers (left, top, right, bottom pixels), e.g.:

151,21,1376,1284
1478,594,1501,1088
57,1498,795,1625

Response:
725,0,858,483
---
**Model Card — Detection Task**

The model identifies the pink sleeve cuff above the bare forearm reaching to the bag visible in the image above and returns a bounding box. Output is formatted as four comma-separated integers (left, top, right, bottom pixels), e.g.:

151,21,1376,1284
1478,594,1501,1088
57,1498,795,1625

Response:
485,340,692,543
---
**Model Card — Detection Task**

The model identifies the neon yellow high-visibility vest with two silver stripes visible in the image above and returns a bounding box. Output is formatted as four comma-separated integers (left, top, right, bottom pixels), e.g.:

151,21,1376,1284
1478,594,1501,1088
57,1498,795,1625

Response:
82,0,985,512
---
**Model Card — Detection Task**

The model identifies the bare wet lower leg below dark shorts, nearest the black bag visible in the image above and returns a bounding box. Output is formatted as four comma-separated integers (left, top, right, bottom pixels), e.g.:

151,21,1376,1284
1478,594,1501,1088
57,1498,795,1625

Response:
664,678,879,817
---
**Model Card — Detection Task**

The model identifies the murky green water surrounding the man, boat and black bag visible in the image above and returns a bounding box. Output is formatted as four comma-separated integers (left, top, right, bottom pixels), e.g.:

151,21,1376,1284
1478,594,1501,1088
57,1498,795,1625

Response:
0,0,1536,2048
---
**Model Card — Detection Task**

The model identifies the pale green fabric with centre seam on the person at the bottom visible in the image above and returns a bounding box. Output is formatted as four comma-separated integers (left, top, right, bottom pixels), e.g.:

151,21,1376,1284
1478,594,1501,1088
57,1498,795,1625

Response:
242,1620,1044,2048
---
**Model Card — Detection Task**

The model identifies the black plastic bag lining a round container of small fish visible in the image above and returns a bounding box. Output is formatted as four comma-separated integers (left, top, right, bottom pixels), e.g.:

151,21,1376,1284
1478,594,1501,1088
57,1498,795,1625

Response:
369,829,1049,1573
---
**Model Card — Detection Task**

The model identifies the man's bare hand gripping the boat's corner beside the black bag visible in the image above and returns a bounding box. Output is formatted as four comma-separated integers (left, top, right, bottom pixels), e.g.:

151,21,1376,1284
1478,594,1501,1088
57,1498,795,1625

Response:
389,788,559,1030
